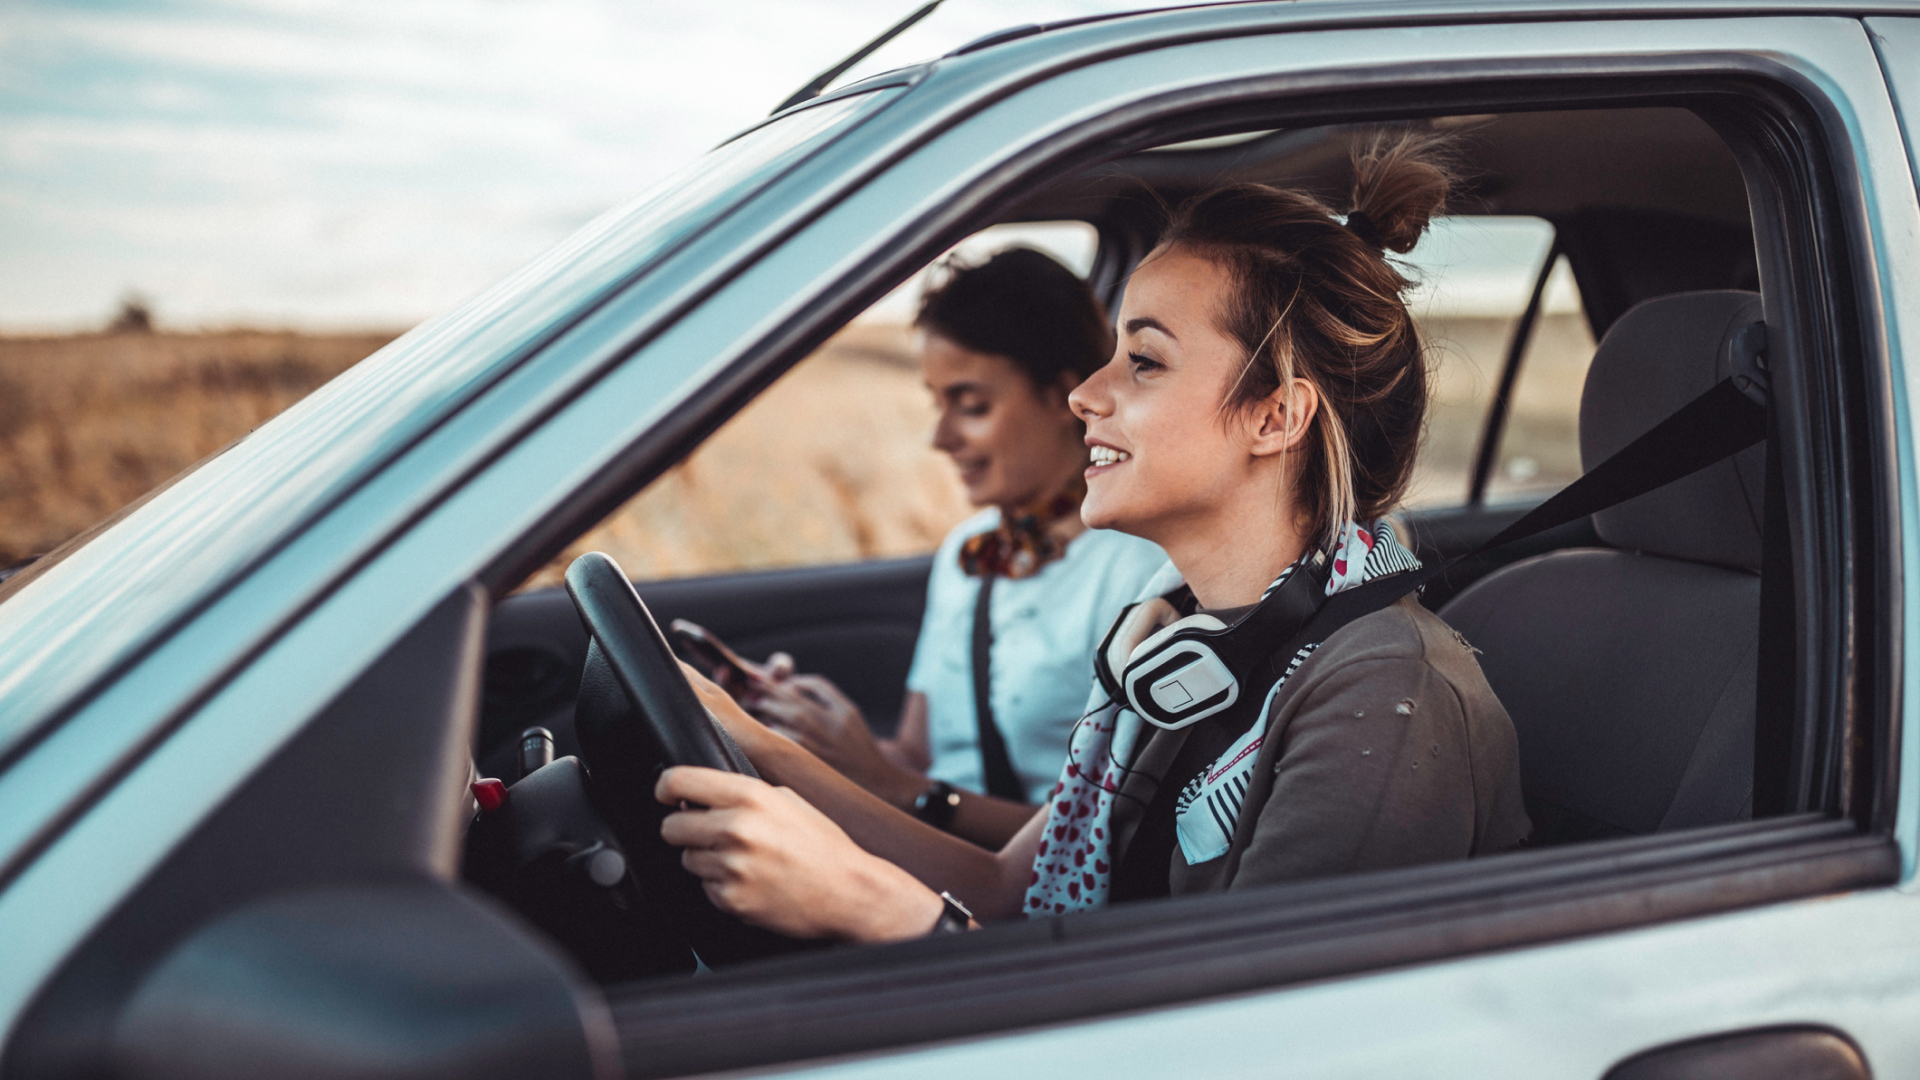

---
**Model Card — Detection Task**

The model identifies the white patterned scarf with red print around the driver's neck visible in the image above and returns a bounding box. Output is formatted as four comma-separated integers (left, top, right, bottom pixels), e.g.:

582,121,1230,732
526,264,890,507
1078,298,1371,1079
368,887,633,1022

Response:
1025,519,1421,919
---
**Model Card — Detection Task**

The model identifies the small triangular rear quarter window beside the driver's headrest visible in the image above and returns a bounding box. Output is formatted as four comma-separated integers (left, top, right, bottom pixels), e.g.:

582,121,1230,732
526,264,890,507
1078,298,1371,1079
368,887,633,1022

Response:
1486,258,1596,503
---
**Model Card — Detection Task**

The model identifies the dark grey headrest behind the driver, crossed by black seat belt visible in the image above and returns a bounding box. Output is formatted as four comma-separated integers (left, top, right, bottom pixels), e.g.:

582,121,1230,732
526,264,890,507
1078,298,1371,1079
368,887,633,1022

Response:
1580,290,1766,573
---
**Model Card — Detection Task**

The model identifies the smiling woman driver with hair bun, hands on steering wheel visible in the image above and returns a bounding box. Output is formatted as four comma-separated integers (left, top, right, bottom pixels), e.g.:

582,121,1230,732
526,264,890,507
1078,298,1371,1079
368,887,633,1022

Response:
655,135,1528,942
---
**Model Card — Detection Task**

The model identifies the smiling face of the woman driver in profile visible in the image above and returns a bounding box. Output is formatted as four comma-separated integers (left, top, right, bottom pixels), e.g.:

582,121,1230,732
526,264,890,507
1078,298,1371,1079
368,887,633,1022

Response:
1071,248,1317,580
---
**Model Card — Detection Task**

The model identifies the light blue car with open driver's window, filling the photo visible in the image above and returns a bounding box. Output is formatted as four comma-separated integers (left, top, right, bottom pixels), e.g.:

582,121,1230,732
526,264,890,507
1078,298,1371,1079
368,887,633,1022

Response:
0,0,1920,1080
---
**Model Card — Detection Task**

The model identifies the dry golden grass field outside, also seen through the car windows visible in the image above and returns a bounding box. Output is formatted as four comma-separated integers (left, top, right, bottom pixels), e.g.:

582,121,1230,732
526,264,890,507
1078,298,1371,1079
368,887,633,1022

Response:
0,315,1592,586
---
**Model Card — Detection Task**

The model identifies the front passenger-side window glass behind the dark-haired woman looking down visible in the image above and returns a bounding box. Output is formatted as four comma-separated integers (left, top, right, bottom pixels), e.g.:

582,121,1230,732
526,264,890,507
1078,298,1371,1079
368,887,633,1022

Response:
522,221,1098,588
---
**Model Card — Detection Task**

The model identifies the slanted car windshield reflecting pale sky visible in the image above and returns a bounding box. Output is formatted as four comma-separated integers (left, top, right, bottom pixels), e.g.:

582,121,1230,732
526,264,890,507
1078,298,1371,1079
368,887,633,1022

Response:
0,88,893,755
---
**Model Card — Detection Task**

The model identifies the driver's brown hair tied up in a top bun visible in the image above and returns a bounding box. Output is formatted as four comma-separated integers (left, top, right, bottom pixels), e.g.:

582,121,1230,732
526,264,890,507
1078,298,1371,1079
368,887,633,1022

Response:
1162,131,1453,540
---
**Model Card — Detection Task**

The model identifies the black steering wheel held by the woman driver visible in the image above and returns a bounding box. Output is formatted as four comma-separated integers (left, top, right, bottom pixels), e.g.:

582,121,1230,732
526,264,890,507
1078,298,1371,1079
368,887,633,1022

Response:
566,552,758,776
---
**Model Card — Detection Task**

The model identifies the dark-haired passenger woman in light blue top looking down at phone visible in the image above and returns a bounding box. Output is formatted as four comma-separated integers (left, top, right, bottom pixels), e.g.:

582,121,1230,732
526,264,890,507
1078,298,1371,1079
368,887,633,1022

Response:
745,248,1167,847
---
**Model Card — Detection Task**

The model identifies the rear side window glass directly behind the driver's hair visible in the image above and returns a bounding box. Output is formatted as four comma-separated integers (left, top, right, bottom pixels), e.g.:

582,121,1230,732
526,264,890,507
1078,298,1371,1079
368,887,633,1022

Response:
1405,215,1578,509
